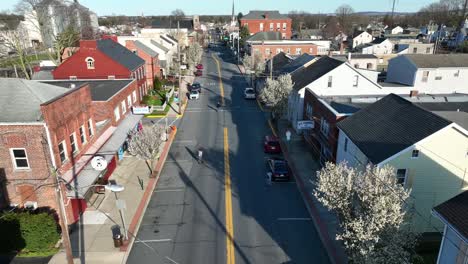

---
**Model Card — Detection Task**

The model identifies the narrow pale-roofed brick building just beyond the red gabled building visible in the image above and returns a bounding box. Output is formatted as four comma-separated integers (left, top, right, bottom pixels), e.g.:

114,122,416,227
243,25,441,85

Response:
125,40,163,87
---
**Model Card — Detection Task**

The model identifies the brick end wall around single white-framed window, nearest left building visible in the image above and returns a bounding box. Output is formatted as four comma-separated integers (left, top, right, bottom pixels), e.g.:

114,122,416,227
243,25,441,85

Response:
0,124,56,208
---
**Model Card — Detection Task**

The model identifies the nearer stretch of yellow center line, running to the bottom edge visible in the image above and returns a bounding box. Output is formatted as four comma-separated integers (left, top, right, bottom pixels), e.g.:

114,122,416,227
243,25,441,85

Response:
224,127,236,264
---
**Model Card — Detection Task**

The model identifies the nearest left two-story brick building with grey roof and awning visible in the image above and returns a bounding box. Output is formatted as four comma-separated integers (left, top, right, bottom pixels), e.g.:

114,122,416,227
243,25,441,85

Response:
0,79,140,223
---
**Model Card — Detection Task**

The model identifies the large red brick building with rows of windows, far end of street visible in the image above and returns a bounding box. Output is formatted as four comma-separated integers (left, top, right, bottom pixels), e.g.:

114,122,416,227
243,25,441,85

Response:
240,10,292,39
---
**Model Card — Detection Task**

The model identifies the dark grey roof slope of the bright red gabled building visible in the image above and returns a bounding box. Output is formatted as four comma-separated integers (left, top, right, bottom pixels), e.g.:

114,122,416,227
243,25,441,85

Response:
96,39,145,71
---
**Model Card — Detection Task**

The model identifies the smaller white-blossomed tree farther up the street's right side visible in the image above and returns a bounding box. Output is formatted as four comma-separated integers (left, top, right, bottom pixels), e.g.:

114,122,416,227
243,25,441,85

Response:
259,74,294,114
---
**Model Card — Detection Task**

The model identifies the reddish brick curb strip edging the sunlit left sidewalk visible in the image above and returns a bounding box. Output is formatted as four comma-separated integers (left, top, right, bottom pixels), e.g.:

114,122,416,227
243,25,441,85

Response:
120,126,177,258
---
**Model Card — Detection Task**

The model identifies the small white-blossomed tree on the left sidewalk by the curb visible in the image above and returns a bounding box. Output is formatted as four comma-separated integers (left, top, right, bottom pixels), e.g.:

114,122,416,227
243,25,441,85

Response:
128,125,165,173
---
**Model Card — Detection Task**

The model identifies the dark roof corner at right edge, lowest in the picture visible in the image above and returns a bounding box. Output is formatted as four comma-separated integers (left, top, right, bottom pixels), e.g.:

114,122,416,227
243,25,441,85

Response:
433,191,468,241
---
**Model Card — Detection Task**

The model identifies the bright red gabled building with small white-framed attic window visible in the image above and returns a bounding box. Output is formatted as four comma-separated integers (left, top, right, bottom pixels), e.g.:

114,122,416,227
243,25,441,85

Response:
52,39,149,100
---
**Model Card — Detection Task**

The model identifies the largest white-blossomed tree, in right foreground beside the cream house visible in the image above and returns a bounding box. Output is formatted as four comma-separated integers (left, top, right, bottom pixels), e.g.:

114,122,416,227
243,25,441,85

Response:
314,163,417,264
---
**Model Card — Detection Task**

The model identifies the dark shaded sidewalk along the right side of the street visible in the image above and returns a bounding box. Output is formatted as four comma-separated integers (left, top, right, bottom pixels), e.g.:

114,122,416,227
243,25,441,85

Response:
276,119,347,264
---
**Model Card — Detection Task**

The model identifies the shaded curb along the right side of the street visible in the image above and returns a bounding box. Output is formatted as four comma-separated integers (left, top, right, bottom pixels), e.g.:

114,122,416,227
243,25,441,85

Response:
279,121,345,264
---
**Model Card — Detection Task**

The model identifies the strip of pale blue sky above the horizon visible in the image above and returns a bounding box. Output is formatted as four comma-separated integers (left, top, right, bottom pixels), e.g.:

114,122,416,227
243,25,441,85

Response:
0,0,438,16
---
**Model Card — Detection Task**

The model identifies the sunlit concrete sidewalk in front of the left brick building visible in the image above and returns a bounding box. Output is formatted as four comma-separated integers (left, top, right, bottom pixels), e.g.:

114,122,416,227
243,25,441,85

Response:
49,129,176,264
